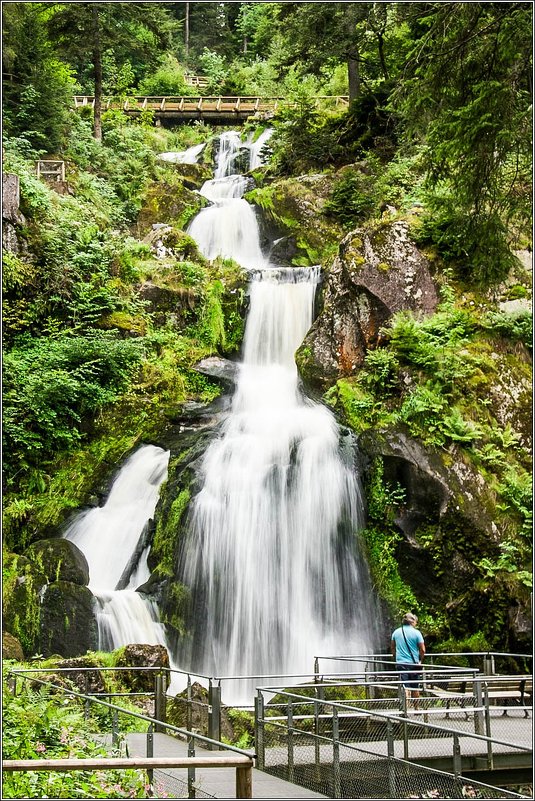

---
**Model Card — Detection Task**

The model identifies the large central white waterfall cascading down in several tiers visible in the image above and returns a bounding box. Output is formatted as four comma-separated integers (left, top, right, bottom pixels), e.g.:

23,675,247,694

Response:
180,126,372,702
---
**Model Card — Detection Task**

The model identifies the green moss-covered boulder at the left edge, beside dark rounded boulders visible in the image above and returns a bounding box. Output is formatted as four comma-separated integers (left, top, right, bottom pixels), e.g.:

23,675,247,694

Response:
2,553,47,656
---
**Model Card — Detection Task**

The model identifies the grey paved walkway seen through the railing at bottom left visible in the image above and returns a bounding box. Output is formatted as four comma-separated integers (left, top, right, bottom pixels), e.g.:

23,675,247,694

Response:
125,732,325,798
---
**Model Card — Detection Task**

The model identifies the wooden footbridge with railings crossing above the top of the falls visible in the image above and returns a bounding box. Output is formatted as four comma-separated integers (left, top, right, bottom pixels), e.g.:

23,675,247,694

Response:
74,95,349,124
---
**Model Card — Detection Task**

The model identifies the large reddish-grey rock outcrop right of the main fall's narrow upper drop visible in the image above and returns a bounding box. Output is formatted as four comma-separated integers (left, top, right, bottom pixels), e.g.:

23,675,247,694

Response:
296,220,438,388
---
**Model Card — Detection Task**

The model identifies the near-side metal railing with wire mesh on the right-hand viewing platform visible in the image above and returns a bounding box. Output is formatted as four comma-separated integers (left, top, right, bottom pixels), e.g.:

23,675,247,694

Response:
256,684,531,798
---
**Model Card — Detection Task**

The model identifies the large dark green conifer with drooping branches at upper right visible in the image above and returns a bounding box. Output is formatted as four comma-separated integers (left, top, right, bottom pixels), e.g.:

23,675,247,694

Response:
393,2,532,282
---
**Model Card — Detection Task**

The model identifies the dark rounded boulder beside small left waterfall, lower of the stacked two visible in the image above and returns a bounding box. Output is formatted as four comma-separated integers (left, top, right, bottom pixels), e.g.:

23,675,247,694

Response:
39,581,98,657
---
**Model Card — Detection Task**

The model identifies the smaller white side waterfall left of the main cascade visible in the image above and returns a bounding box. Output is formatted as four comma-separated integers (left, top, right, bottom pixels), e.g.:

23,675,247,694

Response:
64,445,169,651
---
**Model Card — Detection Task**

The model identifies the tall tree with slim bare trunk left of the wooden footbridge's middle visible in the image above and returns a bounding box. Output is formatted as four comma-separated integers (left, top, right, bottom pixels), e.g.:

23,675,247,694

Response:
49,2,176,140
